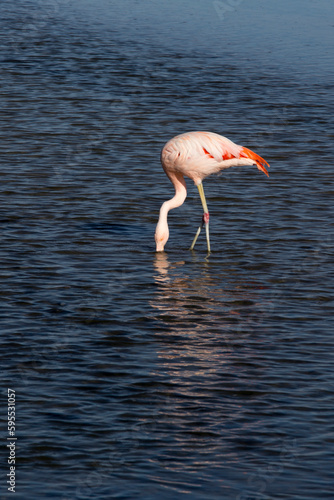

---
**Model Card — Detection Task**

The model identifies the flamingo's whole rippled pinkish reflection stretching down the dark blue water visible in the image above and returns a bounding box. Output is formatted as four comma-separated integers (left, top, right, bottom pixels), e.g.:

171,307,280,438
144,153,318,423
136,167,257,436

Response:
151,253,270,450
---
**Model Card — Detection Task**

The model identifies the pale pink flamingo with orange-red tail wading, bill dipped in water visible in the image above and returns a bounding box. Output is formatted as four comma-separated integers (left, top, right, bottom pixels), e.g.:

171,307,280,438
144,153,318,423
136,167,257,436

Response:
155,132,270,254
